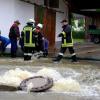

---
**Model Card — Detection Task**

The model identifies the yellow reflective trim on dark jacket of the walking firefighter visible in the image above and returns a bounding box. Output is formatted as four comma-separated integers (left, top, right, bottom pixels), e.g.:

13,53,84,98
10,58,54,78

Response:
61,31,73,47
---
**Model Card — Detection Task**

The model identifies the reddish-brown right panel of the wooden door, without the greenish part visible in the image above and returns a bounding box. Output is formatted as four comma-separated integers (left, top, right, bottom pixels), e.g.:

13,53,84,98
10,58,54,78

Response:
44,9,56,47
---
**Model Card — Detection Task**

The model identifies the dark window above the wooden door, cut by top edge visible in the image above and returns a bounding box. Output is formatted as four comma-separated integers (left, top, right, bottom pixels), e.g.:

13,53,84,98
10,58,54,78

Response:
44,0,59,8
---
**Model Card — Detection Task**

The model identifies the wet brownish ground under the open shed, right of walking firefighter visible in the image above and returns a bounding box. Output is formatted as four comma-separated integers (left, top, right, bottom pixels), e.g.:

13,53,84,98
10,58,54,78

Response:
75,42,100,61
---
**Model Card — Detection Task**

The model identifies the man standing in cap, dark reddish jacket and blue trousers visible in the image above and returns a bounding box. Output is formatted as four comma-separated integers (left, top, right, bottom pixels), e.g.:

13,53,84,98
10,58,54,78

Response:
9,20,20,58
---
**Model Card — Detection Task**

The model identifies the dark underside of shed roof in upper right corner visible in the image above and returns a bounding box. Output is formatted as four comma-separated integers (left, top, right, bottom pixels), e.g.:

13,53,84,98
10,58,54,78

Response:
66,0,100,16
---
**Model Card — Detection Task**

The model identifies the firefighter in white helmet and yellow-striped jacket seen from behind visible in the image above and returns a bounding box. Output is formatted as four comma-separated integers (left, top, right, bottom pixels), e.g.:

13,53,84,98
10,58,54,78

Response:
21,19,35,61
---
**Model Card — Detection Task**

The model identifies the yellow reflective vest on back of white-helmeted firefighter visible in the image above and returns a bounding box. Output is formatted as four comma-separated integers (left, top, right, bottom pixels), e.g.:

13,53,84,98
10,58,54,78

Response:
23,26,35,47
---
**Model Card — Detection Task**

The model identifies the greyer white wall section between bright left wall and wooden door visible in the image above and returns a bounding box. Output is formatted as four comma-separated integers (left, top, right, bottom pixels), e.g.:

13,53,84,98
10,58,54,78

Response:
14,0,34,30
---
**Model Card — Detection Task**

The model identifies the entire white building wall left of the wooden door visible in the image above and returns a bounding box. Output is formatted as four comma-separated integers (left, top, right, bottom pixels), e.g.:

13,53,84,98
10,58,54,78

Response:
0,0,34,37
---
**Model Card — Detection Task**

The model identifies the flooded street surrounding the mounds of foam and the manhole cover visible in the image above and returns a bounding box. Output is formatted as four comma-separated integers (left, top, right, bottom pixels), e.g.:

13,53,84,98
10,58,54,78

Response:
0,58,100,100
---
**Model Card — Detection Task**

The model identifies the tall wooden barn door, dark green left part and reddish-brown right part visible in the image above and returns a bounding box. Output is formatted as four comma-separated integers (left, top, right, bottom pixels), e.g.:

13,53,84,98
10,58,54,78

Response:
35,6,56,47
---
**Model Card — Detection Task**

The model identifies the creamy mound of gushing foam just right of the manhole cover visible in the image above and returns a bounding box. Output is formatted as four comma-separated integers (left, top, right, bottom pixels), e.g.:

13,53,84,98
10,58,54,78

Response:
51,78,81,92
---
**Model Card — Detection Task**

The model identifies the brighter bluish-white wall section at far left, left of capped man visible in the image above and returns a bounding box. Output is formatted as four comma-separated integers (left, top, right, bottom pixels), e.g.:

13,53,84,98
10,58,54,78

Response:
0,0,14,37
